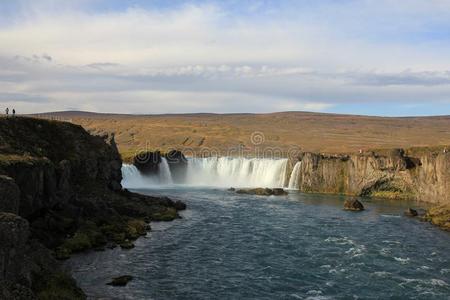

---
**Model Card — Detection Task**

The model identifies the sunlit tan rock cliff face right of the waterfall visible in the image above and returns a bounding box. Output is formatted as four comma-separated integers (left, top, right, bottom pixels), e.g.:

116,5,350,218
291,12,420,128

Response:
292,148,450,204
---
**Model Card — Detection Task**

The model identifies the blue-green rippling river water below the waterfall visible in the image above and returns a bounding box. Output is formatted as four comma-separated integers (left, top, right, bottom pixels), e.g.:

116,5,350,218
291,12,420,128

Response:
68,188,450,299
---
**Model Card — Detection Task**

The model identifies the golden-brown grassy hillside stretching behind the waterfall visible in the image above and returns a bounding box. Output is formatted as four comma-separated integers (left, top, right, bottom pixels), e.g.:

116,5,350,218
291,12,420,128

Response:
33,112,450,158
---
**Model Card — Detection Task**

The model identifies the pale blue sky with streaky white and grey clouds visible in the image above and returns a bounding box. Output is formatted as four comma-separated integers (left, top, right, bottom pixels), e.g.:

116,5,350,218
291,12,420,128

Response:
0,0,450,116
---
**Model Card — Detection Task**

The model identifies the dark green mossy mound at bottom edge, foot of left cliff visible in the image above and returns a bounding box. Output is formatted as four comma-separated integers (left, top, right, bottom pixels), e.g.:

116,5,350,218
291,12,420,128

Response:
36,272,86,300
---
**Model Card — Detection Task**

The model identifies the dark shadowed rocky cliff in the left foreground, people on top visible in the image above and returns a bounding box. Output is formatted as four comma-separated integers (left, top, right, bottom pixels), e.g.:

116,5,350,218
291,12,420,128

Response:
0,117,185,299
